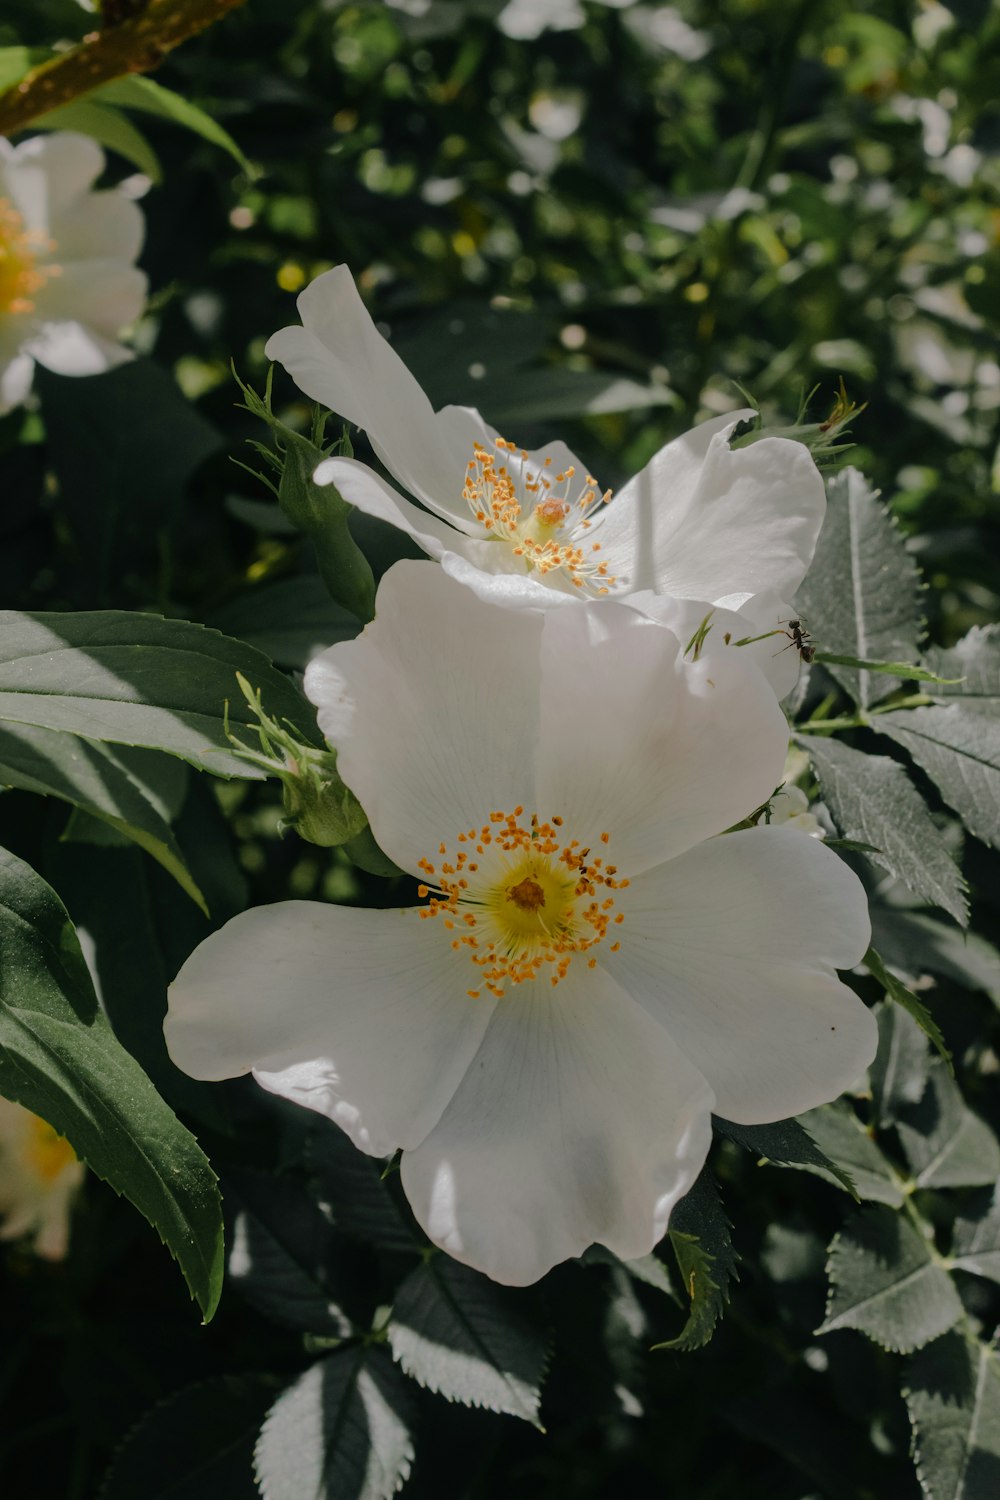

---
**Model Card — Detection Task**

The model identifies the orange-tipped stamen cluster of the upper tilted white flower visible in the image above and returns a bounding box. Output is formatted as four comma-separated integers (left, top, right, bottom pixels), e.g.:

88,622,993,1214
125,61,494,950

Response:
462,438,618,594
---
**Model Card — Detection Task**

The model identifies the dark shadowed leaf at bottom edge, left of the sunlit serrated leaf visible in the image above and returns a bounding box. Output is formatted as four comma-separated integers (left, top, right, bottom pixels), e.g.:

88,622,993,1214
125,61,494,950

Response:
97,1376,276,1500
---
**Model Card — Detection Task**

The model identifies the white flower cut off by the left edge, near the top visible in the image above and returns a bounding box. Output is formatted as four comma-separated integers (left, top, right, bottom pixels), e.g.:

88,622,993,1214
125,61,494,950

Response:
0,132,145,411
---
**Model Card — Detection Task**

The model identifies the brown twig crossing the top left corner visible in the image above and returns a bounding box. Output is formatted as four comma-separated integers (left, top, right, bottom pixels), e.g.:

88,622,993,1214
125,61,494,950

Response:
0,0,243,135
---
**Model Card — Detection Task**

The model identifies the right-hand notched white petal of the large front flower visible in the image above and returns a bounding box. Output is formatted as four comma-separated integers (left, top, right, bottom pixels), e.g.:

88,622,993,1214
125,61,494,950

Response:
611,828,877,1124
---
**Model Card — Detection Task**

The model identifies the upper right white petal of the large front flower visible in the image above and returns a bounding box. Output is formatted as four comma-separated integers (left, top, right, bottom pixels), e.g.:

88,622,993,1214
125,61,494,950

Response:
538,602,789,876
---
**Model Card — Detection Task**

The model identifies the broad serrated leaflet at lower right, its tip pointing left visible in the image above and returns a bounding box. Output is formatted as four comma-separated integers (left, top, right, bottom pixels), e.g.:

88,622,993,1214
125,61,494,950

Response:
817,1206,963,1355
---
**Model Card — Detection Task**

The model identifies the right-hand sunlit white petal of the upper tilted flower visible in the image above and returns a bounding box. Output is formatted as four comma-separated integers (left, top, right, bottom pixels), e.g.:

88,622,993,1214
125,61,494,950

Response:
595,413,826,600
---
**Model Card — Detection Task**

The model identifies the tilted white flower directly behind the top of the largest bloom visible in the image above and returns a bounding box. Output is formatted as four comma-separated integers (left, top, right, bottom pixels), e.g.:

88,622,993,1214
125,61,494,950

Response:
267,266,826,696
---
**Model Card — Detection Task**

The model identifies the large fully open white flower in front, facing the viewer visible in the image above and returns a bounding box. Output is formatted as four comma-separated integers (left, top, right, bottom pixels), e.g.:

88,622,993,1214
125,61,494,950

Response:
165,563,876,1284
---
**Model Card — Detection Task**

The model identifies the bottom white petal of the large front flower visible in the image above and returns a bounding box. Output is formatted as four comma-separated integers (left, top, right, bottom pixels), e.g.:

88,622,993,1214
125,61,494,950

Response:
402,966,712,1286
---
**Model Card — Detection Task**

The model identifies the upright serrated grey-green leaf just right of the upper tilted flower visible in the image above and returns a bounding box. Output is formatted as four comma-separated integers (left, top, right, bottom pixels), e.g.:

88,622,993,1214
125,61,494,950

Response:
796,468,921,708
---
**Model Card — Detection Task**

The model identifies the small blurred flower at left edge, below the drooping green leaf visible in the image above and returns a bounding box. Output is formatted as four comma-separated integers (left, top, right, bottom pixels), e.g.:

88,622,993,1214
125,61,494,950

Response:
0,1100,85,1260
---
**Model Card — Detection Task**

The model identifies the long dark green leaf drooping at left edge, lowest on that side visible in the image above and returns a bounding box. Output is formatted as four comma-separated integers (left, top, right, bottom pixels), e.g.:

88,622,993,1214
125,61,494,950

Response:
0,851,222,1320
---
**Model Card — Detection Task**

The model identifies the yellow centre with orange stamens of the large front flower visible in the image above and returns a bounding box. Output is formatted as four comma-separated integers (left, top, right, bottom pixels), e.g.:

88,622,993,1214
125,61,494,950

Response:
418,807,628,1001
